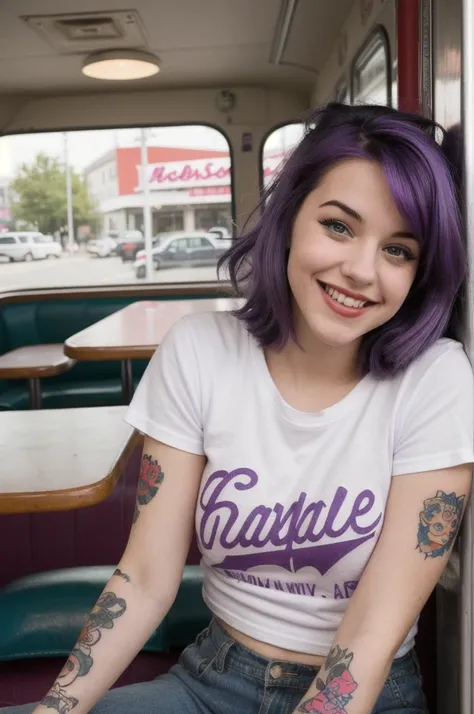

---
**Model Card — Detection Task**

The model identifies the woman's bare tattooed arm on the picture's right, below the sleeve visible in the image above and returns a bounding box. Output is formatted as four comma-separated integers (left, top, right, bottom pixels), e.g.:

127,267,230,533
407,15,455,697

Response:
296,464,472,714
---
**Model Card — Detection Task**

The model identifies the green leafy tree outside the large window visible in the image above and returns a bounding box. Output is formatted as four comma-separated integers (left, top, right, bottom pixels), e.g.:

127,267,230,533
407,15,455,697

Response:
10,153,97,233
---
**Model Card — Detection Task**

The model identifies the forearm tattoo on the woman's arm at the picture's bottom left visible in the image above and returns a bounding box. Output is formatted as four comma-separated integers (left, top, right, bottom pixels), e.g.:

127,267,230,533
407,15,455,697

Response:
41,592,127,714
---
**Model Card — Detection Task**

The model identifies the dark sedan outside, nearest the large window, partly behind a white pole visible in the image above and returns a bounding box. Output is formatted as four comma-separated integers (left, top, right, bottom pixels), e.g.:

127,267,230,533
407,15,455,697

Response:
133,231,231,278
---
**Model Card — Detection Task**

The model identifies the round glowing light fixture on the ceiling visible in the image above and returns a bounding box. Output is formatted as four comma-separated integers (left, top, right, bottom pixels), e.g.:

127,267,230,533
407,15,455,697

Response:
82,50,160,82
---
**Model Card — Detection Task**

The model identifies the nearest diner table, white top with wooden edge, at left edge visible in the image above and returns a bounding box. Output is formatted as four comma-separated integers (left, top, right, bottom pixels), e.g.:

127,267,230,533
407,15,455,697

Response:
0,407,143,513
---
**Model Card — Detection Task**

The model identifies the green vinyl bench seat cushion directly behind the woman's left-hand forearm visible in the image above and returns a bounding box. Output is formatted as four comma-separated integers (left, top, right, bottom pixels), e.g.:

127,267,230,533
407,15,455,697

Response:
0,565,211,662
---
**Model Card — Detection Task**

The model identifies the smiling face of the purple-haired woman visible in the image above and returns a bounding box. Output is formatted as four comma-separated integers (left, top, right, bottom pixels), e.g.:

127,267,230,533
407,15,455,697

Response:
287,159,420,354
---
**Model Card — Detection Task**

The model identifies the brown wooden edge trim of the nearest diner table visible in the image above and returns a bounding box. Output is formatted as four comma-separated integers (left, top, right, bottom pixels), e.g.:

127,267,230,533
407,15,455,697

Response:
0,430,143,515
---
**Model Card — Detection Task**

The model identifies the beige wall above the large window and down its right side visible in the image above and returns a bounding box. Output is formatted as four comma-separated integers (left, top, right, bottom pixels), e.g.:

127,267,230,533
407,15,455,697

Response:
0,87,309,230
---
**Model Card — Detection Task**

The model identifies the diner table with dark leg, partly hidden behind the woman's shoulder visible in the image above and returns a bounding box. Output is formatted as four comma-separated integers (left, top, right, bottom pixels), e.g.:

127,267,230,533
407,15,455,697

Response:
64,297,243,404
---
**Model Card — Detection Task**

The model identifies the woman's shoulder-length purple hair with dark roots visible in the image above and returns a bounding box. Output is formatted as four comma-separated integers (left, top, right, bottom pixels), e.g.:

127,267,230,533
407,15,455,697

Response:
219,104,467,378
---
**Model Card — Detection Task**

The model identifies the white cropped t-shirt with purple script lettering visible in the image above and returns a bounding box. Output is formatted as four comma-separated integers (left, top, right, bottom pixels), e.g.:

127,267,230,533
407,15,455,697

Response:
126,313,474,656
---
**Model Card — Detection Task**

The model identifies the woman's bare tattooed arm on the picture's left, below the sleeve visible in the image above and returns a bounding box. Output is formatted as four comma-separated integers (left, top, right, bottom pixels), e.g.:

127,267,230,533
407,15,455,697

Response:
34,437,205,714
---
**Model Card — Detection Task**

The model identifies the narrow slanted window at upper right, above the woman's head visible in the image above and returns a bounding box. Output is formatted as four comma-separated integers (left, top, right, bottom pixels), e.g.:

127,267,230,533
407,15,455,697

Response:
352,27,392,106
